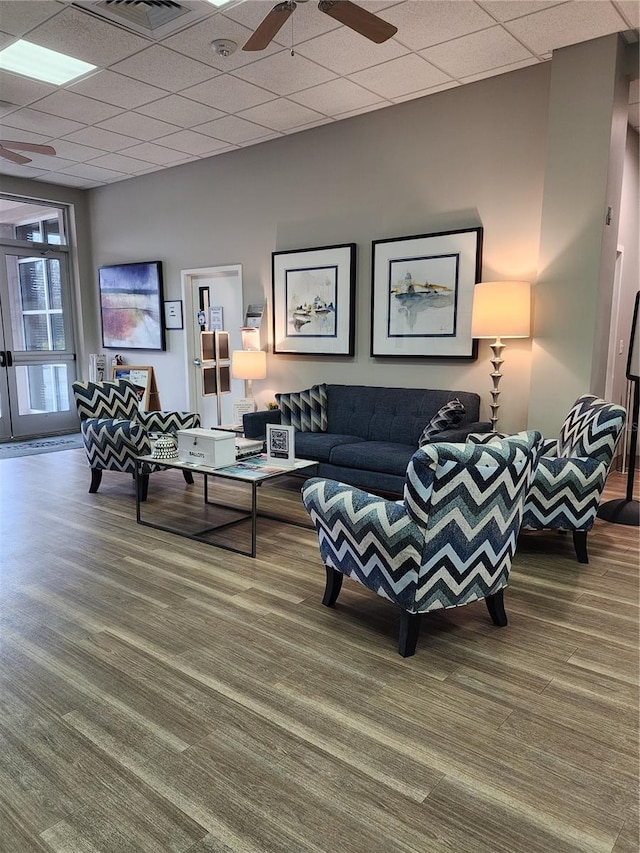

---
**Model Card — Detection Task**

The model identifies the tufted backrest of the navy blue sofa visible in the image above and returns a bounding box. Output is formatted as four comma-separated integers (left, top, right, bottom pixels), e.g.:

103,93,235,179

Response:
326,385,480,447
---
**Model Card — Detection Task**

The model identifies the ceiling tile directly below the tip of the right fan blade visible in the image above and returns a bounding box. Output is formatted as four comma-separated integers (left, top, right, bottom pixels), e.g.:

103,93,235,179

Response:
296,27,407,74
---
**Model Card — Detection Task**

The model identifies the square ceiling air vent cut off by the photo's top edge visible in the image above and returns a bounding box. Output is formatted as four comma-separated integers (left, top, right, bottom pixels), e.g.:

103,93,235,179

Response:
73,0,217,40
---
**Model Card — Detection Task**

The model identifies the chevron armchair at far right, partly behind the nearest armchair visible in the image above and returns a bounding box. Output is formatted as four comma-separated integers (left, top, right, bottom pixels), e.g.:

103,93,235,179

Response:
468,394,627,563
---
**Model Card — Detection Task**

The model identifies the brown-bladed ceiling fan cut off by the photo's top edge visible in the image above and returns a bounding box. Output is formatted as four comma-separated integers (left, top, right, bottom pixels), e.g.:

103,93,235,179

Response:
242,0,398,50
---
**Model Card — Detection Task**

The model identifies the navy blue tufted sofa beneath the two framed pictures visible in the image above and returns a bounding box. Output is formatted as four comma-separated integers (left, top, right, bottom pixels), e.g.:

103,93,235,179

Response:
243,385,491,495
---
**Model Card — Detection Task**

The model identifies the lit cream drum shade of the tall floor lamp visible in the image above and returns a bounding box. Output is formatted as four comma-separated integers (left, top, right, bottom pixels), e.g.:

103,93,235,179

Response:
471,281,531,338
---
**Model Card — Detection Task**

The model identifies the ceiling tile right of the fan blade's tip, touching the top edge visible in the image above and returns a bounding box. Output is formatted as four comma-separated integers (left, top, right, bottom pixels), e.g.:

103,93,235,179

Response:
380,0,495,50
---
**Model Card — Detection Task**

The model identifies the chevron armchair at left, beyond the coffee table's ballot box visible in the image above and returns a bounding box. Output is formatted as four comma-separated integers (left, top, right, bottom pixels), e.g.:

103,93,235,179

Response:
73,379,200,500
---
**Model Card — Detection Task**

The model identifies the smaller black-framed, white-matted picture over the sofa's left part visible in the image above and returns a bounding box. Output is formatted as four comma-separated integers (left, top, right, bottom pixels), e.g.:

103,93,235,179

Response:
271,243,356,357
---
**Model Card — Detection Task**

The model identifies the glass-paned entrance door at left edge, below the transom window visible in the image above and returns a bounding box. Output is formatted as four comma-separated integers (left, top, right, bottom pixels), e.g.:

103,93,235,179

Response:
0,247,78,439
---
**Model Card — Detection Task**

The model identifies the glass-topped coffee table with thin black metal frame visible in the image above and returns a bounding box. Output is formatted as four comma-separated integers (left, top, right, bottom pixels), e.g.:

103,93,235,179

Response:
135,454,318,557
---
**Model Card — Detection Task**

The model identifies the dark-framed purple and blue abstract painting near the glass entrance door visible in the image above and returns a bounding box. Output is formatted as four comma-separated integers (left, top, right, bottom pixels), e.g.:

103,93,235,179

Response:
98,261,166,350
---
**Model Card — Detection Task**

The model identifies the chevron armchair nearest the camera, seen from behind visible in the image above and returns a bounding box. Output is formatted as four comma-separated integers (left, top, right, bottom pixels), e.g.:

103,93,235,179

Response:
302,431,542,657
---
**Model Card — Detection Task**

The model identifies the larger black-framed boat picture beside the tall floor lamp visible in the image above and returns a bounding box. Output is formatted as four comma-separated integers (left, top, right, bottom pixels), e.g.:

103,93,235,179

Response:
371,226,483,361
